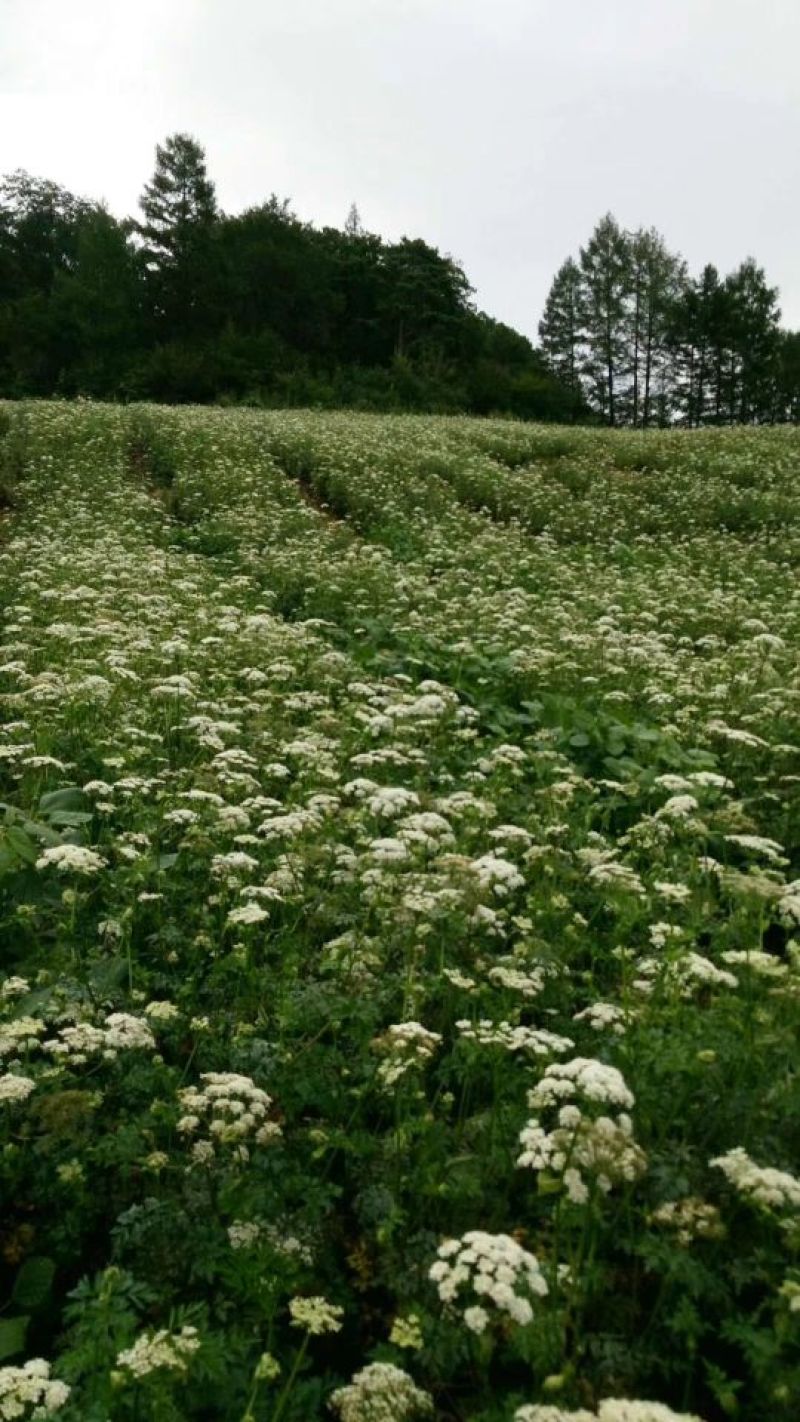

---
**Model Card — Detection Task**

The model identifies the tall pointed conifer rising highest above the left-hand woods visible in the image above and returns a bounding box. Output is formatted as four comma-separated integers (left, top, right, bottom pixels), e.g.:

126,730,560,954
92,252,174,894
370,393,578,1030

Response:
134,134,217,337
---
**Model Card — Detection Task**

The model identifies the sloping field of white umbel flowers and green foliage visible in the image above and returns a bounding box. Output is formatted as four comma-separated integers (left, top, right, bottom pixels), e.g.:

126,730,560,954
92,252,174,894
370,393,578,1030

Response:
0,404,800,1422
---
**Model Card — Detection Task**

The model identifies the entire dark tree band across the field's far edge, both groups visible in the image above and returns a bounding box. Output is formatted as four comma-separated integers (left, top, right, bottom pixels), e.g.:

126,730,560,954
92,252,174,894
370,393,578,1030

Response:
0,134,800,428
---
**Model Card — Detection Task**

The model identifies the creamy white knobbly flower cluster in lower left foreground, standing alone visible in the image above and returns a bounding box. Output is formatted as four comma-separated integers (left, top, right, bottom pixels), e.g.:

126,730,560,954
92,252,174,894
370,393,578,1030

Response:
178,1071,283,1165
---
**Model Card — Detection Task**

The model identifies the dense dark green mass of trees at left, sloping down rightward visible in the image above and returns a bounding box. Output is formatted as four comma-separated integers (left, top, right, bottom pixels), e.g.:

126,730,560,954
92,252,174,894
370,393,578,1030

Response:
0,134,583,419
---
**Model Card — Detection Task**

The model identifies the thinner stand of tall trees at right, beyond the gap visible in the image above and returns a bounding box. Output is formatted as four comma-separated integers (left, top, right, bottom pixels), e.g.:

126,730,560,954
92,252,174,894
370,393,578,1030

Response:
539,213,800,428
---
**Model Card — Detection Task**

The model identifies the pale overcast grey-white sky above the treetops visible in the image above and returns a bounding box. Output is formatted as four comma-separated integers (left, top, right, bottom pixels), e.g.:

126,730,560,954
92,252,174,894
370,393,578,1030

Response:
0,0,800,336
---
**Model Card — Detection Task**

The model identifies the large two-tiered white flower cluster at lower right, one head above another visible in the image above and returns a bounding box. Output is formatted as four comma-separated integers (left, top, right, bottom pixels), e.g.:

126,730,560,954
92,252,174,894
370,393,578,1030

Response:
517,1057,647,1204
